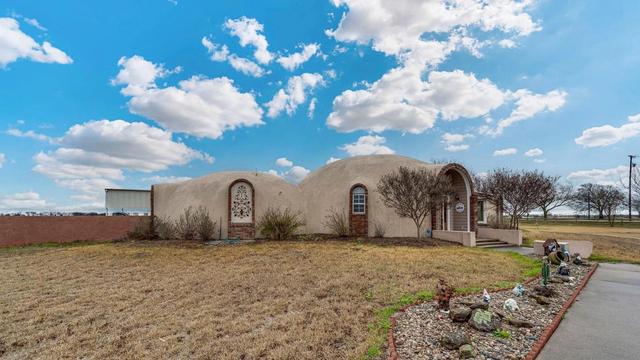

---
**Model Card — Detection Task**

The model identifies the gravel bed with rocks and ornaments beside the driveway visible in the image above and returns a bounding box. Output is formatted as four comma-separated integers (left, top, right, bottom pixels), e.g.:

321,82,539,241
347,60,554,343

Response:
393,264,590,359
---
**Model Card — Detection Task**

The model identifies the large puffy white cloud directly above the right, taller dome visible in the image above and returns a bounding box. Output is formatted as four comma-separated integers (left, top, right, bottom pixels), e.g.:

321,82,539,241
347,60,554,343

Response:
327,67,505,134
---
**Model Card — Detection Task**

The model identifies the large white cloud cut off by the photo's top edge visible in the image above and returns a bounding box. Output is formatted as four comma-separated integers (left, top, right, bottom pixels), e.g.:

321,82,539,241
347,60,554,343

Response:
327,0,540,55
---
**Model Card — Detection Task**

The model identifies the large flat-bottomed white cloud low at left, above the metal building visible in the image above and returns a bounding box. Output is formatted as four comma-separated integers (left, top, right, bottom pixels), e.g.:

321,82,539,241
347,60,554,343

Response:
33,120,214,194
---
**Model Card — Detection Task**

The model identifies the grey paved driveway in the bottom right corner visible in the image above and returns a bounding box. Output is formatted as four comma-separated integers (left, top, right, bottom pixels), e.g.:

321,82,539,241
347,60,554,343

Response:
538,264,640,360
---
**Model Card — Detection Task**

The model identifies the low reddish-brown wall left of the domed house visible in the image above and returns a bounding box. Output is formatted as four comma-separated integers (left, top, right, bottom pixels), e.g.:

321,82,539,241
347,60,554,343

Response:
0,216,145,247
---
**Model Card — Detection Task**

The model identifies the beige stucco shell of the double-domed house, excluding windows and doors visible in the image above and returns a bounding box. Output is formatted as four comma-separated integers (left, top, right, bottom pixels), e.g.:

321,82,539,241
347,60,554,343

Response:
153,155,473,237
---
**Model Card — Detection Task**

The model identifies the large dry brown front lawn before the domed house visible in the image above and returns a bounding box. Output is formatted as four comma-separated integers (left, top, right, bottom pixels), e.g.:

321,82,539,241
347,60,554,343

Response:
0,241,526,359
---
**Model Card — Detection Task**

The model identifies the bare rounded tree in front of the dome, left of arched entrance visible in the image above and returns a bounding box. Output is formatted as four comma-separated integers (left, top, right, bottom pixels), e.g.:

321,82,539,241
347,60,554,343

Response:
378,166,453,238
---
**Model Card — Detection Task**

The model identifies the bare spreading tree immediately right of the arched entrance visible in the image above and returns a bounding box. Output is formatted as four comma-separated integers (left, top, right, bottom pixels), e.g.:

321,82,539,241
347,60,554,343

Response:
476,169,548,229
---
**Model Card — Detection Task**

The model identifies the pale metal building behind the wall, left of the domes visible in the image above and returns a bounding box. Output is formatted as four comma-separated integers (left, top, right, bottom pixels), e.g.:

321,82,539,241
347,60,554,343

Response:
104,189,151,215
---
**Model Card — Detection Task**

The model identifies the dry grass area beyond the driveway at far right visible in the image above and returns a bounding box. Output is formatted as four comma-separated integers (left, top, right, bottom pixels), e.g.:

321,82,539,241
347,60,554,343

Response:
520,223,640,263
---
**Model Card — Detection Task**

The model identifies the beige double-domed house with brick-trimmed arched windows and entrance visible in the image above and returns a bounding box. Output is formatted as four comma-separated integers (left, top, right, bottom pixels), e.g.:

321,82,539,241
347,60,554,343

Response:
151,155,516,246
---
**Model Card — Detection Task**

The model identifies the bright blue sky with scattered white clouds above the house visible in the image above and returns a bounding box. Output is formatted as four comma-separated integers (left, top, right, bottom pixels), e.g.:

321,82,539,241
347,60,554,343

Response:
0,0,640,211
